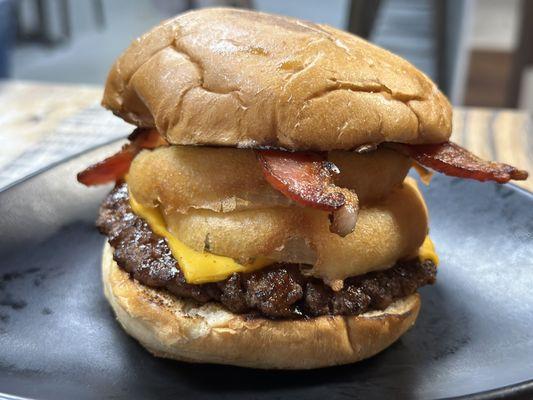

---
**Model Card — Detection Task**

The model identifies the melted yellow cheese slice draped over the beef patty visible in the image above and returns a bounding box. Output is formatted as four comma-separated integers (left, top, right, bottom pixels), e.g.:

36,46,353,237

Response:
129,193,439,284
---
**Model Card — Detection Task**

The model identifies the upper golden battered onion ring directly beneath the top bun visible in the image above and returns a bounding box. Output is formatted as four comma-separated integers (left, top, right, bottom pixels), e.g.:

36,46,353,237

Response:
128,146,411,213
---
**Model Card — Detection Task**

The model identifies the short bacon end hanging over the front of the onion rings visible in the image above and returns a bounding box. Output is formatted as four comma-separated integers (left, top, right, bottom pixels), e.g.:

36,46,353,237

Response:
256,150,359,237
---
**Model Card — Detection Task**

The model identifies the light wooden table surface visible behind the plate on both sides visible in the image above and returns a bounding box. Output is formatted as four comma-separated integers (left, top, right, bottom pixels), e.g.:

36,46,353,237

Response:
0,81,533,191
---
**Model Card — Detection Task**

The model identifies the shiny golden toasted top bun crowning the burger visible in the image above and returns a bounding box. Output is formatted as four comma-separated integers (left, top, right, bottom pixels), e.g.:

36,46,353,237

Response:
102,8,451,151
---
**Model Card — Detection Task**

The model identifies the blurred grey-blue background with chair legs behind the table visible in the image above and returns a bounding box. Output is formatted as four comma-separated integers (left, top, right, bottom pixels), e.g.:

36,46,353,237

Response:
0,0,533,111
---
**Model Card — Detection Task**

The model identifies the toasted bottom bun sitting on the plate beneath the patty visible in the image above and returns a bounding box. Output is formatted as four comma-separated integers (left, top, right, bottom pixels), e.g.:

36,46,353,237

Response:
102,243,420,369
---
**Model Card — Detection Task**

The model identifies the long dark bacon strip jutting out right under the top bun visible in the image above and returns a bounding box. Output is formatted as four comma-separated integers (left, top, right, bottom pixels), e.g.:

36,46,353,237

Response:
389,142,528,183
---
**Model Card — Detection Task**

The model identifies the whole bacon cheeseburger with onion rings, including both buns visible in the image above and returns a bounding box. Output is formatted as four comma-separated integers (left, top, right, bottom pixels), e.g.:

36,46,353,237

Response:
78,9,527,369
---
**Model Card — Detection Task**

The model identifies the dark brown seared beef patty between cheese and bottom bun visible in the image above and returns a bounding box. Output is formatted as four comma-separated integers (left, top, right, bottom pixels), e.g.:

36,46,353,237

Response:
97,183,436,318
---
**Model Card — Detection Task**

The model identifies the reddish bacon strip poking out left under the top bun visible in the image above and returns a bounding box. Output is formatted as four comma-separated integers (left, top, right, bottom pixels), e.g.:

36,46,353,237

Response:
77,128,168,186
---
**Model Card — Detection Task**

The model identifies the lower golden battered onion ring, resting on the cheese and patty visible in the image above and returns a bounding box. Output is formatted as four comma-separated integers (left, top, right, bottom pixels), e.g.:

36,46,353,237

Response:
165,178,428,281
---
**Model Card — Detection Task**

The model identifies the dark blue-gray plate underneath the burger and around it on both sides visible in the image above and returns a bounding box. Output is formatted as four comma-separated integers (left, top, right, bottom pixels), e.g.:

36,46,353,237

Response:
0,144,533,400
